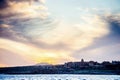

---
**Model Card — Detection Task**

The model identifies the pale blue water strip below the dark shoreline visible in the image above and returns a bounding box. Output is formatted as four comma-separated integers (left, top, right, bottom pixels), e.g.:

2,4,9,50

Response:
0,74,120,80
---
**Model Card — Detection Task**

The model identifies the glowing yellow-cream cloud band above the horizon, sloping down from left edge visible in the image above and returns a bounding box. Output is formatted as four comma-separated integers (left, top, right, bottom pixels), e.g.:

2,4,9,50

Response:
0,39,72,65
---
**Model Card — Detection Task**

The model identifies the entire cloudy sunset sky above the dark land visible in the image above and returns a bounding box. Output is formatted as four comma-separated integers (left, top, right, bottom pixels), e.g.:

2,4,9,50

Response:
0,0,120,67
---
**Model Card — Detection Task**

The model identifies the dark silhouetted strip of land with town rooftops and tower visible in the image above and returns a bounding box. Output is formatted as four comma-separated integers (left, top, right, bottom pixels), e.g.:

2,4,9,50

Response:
0,59,120,74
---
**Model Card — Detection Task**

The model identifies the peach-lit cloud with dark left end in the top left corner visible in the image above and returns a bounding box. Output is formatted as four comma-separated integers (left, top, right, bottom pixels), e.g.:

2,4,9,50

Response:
0,0,48,19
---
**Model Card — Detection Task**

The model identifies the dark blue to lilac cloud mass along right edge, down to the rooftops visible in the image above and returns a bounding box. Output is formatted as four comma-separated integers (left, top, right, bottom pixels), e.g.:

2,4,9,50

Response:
72,13,120,61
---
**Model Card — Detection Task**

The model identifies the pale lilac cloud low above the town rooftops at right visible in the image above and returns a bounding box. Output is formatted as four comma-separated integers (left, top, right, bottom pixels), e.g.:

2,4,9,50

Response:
73,44,120,62
